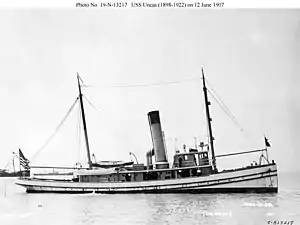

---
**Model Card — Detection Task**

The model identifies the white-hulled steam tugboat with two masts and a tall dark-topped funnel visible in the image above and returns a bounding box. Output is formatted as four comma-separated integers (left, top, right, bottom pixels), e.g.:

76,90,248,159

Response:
16,68,278,194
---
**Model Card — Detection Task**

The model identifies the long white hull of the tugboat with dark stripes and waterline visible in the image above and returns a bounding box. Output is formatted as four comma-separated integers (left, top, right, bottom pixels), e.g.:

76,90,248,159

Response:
16,164,278,193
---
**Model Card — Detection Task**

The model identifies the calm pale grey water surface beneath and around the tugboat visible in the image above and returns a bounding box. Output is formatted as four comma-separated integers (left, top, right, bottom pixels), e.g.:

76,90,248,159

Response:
0,171,300,225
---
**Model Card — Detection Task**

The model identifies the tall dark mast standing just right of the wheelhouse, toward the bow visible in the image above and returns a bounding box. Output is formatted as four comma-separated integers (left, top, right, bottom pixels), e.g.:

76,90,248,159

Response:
202,67,217,171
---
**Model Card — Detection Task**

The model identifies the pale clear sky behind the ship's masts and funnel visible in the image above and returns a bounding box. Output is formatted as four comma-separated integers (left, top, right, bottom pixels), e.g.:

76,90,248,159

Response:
0,9,300,171
